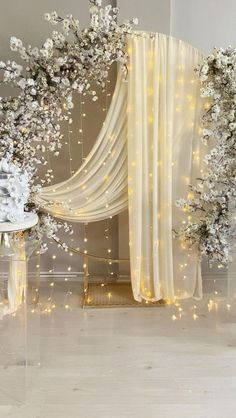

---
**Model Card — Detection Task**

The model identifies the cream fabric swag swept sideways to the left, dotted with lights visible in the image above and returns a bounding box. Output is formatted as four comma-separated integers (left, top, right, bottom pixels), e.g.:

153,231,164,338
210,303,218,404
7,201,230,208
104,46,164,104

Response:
38,71,128,222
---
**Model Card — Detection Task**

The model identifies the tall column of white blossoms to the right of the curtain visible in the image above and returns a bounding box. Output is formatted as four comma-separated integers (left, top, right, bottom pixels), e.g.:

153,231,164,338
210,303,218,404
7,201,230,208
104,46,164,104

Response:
176,47,236,265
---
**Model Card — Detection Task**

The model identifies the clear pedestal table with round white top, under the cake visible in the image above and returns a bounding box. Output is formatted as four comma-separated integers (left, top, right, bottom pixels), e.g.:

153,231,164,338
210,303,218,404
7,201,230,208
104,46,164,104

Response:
0,213,40,405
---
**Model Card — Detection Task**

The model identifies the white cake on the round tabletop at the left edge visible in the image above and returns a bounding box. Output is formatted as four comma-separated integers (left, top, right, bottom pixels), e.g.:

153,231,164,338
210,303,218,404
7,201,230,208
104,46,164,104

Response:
0,158,29,223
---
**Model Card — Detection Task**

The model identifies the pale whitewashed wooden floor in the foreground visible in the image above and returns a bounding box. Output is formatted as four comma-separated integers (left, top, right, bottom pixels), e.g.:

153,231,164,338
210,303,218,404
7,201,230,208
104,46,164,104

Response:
0,283,236,418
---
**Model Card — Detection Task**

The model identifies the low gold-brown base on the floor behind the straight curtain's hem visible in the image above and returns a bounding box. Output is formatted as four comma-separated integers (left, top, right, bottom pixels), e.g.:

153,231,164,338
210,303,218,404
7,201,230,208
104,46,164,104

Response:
83,282,166,308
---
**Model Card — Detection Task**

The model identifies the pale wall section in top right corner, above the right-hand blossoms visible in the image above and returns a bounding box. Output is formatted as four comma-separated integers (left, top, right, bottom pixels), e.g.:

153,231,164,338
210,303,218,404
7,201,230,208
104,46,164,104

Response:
171,0,236,53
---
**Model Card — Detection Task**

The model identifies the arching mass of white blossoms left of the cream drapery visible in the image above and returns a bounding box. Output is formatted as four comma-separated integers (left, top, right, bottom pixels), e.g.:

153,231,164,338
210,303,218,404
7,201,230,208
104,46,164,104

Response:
0,0,134,248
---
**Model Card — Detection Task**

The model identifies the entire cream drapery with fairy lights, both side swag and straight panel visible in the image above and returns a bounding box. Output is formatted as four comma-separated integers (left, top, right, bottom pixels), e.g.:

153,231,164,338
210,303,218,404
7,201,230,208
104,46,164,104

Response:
39,33,202,301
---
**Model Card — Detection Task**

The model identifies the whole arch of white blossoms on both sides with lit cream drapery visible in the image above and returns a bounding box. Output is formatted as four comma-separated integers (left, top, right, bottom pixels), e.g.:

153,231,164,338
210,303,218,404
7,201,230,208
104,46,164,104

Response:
0,0,236,301
